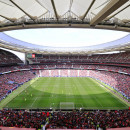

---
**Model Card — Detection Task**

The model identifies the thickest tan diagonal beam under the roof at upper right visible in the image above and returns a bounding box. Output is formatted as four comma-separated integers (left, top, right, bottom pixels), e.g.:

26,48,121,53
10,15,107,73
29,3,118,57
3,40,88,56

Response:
90,0,129,26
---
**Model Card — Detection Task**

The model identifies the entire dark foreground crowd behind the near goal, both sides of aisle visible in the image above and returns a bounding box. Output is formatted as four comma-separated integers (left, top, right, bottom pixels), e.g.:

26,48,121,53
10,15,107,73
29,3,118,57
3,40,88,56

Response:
0,109,130,129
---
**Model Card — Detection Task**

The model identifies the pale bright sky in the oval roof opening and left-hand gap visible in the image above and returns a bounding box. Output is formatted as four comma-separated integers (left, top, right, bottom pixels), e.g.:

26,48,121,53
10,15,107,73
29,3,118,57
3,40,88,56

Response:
4,28,129,60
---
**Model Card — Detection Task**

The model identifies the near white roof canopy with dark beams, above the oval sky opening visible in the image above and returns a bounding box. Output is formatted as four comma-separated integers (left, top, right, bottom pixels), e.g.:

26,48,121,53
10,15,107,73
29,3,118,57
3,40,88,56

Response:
0,0,130,32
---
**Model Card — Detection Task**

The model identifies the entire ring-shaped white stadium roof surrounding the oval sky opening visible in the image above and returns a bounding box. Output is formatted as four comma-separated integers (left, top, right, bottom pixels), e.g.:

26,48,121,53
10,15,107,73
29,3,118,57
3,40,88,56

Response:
0,0,130,54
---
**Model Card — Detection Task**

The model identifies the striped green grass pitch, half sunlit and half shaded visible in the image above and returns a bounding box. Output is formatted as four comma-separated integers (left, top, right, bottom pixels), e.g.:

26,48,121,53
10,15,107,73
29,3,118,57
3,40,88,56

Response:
1,77,129,109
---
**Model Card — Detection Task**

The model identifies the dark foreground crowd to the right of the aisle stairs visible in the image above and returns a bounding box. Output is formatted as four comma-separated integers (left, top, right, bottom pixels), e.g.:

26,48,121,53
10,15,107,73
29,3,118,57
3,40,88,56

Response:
46,110,130,129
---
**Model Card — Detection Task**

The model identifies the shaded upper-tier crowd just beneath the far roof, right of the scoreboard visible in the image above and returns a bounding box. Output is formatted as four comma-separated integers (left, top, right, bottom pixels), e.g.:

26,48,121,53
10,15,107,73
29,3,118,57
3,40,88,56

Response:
29,52,130,63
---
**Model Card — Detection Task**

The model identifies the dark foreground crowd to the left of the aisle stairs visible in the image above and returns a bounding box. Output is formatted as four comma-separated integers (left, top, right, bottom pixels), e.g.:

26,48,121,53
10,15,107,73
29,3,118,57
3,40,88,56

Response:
0,109,47,129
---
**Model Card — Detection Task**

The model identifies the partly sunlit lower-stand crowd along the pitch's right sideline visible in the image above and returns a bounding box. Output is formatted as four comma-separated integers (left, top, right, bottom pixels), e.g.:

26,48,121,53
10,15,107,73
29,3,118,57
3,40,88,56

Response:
89,70,130,97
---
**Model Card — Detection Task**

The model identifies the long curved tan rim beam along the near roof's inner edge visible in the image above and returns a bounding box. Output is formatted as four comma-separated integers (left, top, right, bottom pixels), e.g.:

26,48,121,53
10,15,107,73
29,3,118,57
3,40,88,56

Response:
0,23,130,32
